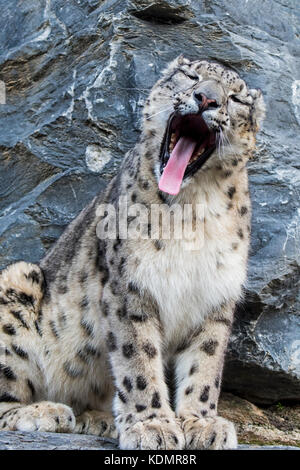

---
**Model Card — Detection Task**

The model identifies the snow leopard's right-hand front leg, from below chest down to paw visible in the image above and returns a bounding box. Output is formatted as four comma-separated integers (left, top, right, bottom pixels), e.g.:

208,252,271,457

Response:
176,303,237,449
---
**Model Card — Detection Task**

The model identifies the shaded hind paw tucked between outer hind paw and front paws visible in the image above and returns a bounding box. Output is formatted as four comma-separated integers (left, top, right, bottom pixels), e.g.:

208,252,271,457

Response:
74,410,118,439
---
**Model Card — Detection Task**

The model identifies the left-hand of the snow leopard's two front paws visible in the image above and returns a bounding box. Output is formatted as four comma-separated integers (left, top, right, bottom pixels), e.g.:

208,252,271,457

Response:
119,418,185,450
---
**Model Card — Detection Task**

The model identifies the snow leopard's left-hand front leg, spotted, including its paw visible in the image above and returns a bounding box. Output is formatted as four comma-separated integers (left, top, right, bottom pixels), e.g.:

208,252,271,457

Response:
102,285,184,450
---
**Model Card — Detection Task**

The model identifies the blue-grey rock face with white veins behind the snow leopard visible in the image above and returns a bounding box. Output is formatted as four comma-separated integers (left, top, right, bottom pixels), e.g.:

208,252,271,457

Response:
0,0,300,403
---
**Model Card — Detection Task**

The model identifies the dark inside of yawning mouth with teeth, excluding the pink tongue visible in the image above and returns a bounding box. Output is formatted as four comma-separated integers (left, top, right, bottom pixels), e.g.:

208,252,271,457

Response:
160,112,217,179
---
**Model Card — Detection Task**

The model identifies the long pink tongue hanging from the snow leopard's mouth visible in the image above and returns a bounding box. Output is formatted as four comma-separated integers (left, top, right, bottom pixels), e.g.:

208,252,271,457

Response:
158,137,197,195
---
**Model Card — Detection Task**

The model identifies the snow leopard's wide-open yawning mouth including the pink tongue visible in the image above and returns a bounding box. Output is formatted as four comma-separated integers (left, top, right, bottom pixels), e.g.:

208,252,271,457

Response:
159,113,216,195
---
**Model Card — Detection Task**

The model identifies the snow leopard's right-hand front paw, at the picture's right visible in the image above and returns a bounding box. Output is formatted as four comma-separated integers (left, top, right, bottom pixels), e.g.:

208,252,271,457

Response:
182,416,238,450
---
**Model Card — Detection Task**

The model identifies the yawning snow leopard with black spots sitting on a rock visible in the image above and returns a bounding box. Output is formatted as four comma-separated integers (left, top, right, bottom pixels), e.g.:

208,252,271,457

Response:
0,56,264,449
